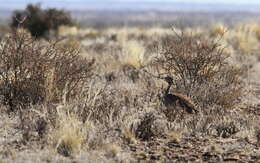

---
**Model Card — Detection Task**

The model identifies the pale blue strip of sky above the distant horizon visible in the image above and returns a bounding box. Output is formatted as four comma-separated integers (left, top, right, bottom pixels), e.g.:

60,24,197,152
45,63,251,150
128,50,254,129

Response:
0,0,260,10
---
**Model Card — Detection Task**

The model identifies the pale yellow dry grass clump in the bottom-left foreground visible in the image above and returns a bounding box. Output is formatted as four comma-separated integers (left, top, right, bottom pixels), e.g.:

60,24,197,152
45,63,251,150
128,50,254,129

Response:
49,110,95,157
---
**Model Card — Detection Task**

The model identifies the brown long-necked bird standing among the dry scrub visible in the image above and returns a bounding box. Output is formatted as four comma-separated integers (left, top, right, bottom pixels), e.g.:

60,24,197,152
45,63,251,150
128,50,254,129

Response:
163,76,198,114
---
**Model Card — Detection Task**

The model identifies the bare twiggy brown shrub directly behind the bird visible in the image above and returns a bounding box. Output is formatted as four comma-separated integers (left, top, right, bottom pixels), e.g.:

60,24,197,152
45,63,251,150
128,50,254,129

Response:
155,33,242,110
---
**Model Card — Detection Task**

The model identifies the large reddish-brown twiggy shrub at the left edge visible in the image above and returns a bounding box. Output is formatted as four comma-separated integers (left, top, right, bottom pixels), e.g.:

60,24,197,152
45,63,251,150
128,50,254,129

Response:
0,30,94,111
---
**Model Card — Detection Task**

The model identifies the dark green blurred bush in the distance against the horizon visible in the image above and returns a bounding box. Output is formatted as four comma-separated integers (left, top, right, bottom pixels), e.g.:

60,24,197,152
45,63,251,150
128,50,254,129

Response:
10,4,74,37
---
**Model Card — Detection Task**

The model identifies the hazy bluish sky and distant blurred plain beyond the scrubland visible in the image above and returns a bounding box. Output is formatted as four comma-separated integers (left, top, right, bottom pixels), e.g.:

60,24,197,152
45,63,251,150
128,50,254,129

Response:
0,0,260,28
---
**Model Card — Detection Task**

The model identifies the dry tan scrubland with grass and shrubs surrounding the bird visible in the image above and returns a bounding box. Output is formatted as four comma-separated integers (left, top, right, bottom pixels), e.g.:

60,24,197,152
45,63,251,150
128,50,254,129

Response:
0,5,260,162
